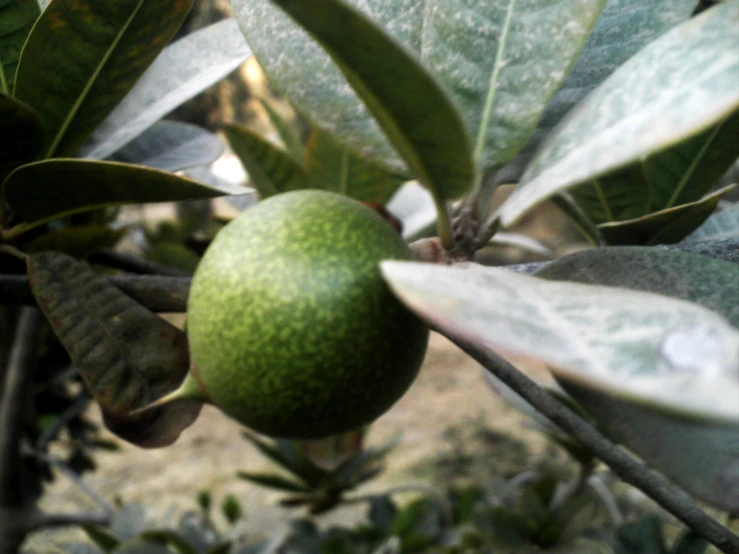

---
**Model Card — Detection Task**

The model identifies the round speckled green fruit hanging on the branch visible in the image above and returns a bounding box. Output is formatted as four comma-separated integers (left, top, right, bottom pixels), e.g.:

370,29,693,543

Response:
187,190,429,439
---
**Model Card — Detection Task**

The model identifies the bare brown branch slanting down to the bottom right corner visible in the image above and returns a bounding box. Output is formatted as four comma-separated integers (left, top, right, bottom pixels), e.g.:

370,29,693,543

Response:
445,333,739,553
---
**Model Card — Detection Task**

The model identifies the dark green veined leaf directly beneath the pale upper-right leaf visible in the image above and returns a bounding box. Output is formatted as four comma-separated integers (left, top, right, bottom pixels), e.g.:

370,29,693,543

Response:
570,113,739,223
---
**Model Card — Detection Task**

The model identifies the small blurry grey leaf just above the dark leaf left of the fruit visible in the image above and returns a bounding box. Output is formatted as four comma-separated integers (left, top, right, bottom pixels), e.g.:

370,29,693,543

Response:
109,121,225,172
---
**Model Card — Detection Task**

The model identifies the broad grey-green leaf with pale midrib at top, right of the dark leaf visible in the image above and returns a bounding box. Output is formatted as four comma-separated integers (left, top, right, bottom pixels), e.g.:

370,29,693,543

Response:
436,0,606,171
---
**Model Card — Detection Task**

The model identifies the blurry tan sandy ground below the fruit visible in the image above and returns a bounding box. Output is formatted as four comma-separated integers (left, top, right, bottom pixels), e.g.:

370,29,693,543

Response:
26,335,564,553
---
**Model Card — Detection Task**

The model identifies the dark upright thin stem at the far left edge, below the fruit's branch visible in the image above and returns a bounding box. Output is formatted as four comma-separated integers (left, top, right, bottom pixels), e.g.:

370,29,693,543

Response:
0,308,41,506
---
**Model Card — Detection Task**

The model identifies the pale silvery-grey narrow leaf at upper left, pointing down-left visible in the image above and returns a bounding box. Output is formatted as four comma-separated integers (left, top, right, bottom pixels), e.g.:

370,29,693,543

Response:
79,19,251,159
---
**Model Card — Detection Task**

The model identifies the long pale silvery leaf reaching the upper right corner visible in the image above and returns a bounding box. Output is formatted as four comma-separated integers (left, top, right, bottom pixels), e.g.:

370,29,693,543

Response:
499,0,739,226
